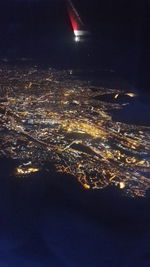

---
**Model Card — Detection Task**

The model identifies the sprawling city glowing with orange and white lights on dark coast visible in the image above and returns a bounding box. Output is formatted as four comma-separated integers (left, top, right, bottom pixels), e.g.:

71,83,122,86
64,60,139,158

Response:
0,64,150,196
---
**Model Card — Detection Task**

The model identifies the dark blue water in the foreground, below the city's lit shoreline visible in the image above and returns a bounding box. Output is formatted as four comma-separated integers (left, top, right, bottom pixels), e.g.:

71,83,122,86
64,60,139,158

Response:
0,159,150,266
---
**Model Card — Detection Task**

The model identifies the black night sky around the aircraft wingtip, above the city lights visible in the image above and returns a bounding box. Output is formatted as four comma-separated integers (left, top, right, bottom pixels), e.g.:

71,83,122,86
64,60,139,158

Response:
0,0,147,78
